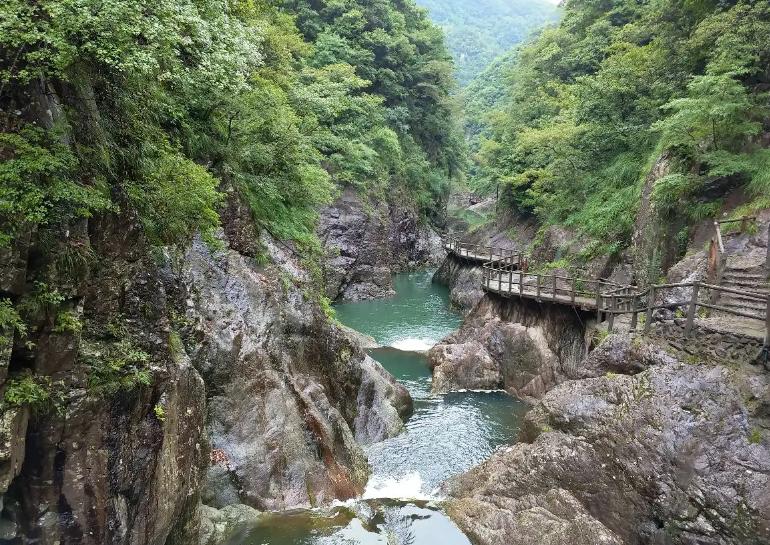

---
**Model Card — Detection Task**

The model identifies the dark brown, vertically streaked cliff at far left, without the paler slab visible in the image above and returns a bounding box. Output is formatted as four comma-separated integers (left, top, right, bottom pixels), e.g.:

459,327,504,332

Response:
0,218,207,545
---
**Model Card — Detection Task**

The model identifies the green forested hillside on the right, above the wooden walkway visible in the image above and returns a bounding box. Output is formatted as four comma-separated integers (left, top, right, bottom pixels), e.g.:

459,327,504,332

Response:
473,0,770,253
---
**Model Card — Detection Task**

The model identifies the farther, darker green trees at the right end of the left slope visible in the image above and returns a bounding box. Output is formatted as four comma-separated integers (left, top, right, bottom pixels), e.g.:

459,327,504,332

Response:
284,0,464,216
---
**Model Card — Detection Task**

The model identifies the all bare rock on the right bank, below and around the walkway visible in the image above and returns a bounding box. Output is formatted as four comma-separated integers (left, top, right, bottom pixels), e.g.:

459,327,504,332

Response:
429,206,770,545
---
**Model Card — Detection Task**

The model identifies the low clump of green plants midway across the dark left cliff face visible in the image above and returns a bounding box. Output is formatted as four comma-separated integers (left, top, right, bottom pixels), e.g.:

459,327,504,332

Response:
79,338,152,396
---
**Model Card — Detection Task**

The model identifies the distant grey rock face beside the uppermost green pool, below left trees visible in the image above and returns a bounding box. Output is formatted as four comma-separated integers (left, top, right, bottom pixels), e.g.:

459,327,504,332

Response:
318,189,444,300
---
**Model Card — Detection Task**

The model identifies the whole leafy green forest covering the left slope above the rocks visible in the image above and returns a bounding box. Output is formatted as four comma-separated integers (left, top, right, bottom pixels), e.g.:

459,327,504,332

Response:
0,0,460,262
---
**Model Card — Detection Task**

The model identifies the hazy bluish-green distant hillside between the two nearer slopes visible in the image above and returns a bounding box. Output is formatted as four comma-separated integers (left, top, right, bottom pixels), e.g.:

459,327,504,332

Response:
418,0,556,86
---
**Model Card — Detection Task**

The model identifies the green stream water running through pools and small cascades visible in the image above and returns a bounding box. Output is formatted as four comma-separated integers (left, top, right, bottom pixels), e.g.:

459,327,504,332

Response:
220,272,526,545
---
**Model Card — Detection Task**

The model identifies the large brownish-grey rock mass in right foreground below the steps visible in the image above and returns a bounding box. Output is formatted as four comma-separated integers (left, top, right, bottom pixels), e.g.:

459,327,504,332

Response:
449,337,770,545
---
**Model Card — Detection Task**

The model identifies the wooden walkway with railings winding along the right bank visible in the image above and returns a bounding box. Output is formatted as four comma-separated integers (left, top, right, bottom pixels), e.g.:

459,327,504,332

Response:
444,238,770,350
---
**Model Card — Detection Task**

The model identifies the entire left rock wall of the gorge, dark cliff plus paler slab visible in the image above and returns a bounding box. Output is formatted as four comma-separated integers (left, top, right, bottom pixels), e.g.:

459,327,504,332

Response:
0,197,411,545
